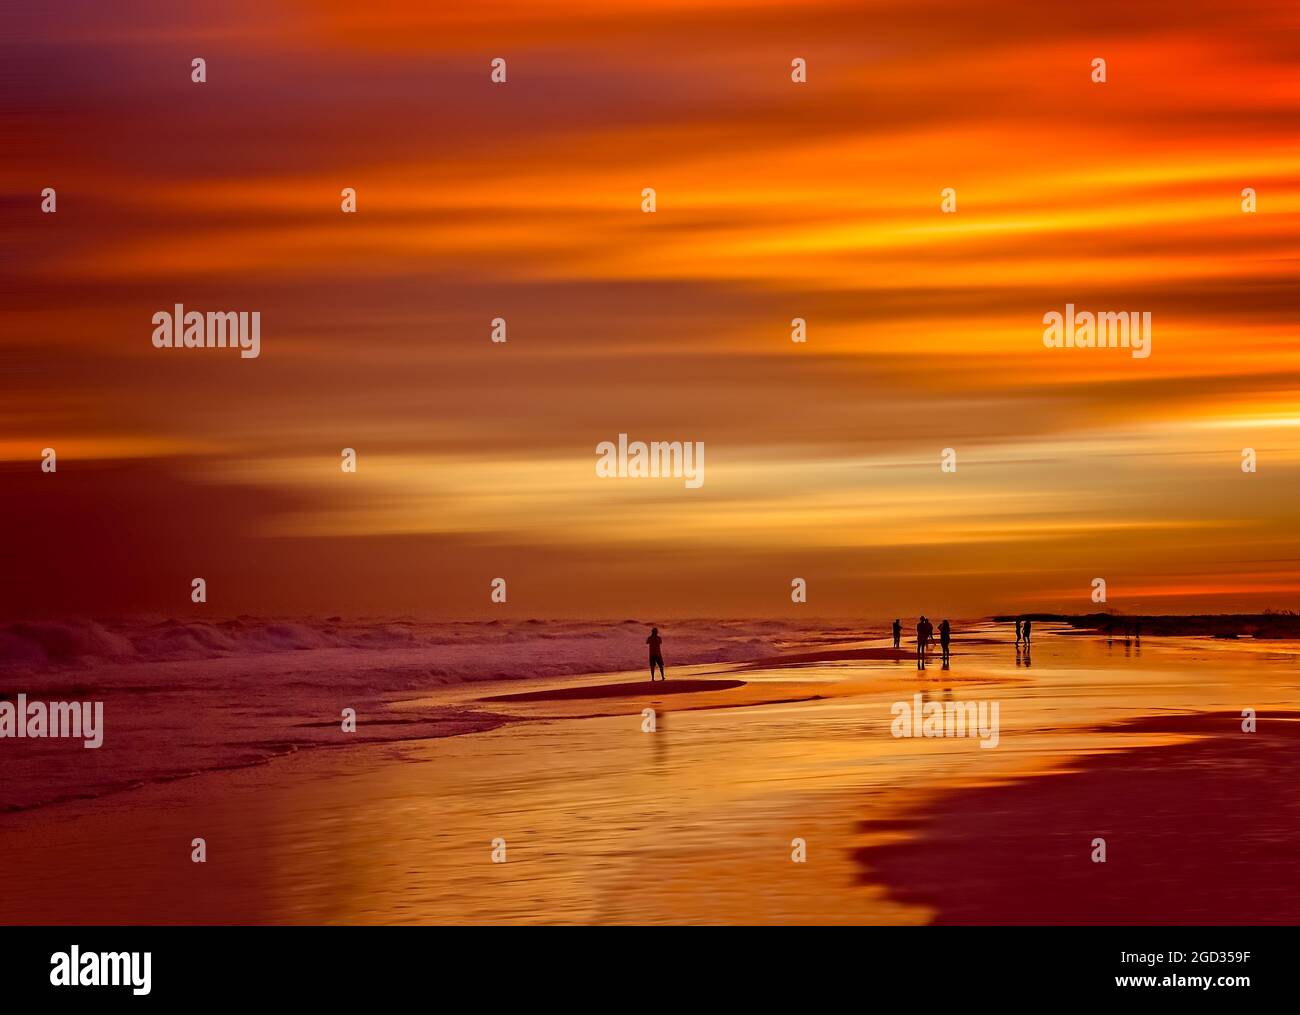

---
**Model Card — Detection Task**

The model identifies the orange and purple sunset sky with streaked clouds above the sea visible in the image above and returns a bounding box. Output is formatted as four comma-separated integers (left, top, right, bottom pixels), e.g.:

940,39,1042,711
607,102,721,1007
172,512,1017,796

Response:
0,0,1300,623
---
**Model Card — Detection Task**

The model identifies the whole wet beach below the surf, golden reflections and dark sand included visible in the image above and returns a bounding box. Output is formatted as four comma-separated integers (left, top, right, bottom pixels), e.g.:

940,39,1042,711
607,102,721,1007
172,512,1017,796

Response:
0,621,1300,924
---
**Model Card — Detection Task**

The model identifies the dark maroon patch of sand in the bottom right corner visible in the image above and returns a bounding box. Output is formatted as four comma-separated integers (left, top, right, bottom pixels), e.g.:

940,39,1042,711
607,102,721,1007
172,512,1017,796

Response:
858,712,1300,925
